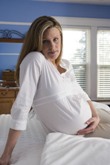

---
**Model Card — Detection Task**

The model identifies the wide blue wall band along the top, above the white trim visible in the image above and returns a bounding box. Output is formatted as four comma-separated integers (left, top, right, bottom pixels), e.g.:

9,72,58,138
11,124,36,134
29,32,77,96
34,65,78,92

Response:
0,0,110,22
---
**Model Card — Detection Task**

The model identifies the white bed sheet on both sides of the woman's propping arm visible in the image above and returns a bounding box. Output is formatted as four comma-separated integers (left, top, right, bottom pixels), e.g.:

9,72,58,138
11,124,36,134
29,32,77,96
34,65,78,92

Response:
0,115,46,165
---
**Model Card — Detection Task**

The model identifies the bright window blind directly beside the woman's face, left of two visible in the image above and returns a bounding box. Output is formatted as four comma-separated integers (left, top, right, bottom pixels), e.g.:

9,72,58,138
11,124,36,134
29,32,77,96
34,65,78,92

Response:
63,28,89,91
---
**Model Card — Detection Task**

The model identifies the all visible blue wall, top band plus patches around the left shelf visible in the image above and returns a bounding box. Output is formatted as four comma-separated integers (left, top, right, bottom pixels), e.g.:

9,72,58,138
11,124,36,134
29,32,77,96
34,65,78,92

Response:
0,0,110,78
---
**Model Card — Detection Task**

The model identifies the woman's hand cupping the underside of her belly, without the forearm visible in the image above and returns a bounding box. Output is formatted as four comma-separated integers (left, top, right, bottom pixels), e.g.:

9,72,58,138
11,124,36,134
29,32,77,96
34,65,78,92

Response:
77,116,100,135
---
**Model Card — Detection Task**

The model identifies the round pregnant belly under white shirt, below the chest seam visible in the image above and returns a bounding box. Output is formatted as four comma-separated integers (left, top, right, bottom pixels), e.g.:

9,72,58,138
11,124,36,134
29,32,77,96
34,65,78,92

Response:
37,98,92,134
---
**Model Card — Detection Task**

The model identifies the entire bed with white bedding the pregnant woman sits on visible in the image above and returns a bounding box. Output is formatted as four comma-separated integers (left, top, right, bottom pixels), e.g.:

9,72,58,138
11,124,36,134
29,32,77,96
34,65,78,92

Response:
0,102,110,165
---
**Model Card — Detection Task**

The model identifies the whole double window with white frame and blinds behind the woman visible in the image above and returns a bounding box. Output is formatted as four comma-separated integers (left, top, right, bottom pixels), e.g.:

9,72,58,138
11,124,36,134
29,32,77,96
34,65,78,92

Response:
55,17,110,101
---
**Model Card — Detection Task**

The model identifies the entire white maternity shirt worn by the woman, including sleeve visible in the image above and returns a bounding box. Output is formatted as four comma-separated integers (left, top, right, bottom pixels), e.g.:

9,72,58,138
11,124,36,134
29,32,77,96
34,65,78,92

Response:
11,52,92,134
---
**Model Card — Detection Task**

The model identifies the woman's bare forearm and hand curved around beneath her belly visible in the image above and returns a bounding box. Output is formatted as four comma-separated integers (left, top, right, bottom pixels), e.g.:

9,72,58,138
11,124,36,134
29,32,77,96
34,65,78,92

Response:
77,100,100,135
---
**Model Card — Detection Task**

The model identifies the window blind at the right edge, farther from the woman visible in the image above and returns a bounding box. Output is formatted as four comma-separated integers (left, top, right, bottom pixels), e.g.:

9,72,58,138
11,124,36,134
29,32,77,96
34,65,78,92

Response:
97,30,110,99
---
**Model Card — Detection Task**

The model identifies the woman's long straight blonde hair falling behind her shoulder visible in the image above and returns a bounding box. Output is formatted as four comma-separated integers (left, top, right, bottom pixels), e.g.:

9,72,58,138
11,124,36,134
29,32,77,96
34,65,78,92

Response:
16,16,63,83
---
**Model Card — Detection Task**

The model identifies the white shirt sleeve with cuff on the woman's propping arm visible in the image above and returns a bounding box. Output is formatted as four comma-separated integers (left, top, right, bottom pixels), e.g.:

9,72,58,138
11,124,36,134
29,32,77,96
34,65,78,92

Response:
11,52,42,130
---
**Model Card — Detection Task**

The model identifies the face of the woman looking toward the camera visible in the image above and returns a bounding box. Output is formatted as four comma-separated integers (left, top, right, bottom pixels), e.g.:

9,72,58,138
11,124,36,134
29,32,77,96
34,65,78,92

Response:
42,27,61,63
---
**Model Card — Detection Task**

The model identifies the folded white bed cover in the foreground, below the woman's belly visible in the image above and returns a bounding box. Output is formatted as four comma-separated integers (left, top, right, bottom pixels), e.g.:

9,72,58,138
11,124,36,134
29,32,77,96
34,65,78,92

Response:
40,132,110,165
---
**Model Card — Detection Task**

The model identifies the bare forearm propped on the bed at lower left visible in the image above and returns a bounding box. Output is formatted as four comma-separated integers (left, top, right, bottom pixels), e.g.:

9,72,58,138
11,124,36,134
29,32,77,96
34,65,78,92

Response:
0,129,21,165
